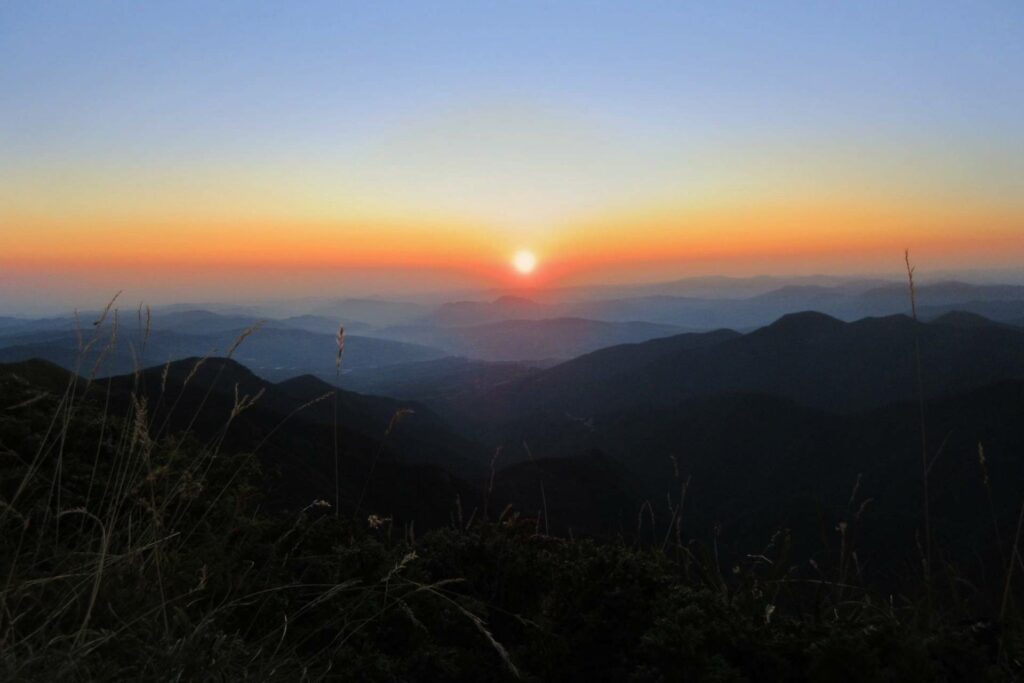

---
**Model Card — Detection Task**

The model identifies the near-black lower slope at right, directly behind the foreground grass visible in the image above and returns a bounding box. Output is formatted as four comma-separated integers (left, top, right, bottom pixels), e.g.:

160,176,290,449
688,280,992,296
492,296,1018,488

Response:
483,381,1024,581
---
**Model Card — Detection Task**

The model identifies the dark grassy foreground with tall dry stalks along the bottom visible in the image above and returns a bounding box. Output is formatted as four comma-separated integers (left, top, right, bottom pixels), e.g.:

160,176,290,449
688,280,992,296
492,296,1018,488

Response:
0,294,1024,681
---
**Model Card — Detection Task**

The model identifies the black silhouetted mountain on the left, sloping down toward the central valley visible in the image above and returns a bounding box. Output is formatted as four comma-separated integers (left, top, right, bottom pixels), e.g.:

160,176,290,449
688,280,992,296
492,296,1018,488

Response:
0,358,482,527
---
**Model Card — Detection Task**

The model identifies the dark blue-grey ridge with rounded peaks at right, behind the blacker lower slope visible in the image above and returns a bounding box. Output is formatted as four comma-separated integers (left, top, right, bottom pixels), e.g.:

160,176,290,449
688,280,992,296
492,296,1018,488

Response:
480,312,1024,416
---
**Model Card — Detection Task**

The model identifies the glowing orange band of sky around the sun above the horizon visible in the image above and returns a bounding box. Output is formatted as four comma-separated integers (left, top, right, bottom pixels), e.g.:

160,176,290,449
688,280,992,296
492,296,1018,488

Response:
0,192,1024,294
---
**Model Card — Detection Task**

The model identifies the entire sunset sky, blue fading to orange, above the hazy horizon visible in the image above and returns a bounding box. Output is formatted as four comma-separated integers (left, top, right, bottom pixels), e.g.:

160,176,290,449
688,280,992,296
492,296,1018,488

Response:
0,0,1024,305
